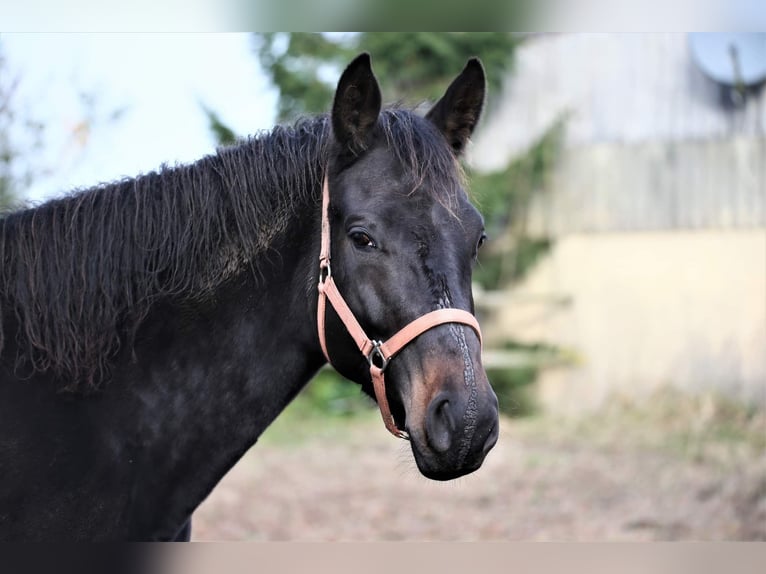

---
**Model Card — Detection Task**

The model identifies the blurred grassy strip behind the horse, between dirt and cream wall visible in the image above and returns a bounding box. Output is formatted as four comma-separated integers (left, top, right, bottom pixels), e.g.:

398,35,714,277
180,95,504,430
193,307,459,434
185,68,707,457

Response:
266,369,766,472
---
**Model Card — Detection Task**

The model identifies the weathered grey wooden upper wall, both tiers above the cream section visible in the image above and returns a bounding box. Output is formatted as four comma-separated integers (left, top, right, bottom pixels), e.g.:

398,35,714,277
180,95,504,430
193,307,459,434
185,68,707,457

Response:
471,34,766,235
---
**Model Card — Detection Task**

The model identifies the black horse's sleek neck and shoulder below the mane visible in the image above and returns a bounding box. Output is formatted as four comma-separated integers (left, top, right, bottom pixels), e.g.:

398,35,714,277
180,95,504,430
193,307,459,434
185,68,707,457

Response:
0,151,323,540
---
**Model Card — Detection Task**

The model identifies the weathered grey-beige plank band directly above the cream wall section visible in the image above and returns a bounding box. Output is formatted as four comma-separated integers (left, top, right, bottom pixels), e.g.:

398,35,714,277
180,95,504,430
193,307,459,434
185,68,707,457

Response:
529,136,766,237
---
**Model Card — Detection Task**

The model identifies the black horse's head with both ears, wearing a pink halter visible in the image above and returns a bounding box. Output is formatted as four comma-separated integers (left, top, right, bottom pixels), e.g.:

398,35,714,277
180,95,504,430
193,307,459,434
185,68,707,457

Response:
319,54,498,480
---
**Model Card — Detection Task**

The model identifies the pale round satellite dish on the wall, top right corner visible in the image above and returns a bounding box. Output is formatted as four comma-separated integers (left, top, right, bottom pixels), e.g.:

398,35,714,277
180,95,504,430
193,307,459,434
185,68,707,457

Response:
689,32,766,91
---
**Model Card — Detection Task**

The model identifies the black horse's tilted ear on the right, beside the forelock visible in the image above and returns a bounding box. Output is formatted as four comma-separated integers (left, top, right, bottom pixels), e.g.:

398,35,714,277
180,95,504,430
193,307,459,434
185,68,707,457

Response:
426,58,487,156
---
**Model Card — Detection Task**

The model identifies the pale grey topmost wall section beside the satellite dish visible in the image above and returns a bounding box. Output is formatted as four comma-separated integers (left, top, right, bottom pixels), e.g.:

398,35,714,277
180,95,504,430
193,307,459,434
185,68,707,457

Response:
471,34,766,165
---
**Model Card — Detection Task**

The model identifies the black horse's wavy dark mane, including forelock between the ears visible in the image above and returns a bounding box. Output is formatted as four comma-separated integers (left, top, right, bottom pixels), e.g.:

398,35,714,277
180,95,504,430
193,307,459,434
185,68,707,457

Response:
0,108,462,391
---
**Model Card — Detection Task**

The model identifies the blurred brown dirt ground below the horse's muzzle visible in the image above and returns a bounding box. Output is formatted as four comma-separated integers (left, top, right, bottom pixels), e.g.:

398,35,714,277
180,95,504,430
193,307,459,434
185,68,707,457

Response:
192,402,766,541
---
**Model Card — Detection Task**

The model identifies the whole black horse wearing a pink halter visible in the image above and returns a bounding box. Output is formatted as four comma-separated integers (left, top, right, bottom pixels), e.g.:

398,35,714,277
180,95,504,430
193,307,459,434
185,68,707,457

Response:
0,53,499,541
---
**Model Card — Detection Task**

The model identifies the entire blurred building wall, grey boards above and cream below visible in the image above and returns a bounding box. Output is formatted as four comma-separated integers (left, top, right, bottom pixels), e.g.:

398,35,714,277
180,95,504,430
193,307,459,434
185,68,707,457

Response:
470,34,766,411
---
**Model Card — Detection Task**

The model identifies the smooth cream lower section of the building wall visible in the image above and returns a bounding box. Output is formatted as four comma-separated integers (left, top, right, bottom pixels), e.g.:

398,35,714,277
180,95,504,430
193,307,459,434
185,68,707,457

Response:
482,230,766,412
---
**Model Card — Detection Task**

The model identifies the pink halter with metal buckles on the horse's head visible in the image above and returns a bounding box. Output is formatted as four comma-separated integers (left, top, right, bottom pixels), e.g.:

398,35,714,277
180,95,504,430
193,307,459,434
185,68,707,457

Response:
317,174,481,439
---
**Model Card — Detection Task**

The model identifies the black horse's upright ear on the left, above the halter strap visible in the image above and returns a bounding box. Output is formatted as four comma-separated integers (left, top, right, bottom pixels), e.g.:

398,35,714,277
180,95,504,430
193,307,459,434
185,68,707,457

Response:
332,52,381,153
